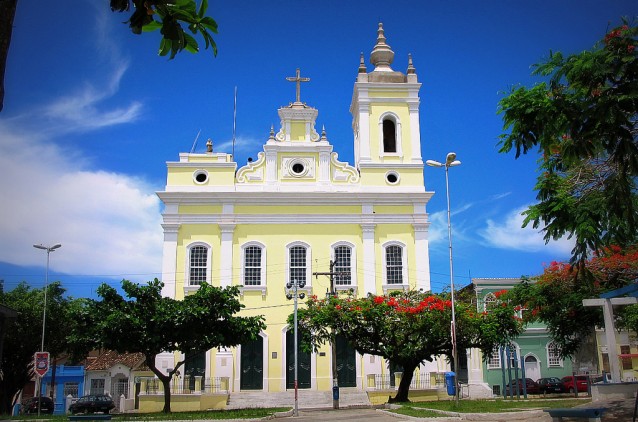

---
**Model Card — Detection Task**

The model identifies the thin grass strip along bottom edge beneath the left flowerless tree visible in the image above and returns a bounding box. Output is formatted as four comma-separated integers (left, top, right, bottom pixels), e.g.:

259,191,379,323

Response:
11,407,291,422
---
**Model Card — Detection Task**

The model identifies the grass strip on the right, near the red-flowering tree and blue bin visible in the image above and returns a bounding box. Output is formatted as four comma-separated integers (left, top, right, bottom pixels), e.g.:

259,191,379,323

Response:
400,399,591,413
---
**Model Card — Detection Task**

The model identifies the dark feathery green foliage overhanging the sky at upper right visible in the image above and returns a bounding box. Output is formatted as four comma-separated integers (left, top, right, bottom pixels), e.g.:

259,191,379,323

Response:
499,23,638,264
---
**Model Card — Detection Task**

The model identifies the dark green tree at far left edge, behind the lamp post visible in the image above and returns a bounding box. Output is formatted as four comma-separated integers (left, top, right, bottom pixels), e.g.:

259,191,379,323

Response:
0,282,79,414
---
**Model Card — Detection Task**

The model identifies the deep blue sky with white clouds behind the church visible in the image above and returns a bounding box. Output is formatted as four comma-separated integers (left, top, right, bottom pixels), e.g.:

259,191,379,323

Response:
0,0,638,297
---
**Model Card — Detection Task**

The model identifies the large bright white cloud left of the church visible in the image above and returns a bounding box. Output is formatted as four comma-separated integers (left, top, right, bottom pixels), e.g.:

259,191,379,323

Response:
0,121,162,280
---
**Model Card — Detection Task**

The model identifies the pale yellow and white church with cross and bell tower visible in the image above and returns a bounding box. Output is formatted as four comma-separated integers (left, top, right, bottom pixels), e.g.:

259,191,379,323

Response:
158,24,446,391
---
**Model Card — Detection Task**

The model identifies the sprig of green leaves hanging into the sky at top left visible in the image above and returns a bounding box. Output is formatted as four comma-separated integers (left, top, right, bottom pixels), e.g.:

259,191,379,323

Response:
111,0,217,59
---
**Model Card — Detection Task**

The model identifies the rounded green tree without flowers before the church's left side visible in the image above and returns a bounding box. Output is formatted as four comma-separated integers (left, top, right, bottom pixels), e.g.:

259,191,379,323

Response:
69,279,265,413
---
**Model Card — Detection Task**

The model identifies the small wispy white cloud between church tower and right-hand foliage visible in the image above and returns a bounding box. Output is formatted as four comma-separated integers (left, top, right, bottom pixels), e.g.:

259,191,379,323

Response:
479,207,574,256
